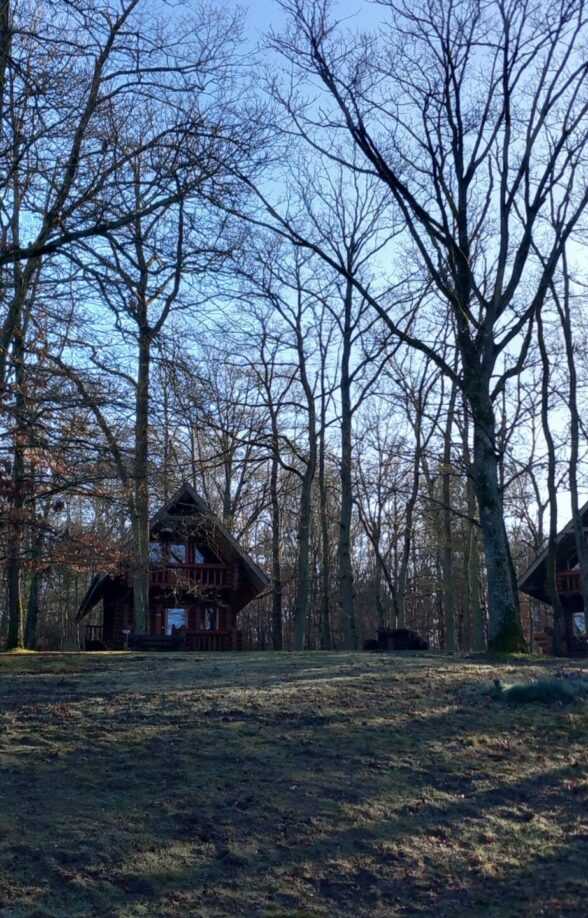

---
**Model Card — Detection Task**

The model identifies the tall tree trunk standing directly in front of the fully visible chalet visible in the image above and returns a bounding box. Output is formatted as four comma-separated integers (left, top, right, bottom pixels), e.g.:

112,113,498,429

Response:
133,326,151,634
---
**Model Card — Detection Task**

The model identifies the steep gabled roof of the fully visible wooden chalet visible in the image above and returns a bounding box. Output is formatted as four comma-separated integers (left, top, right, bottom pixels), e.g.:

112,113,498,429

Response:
76,481,269,622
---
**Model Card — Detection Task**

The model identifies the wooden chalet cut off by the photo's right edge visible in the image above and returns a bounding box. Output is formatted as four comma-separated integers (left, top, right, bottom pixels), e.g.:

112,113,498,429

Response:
519,504,588,656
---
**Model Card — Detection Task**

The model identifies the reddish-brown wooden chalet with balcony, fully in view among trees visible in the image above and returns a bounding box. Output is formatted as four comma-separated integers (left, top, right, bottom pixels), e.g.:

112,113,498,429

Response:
77,482,268,651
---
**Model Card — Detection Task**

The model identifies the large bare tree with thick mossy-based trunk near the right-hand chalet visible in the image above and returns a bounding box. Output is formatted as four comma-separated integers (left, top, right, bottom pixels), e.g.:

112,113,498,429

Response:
266,0,588,649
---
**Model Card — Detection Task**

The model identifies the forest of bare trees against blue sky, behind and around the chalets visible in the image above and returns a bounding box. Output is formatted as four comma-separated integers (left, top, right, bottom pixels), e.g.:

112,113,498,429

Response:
0,0,588,650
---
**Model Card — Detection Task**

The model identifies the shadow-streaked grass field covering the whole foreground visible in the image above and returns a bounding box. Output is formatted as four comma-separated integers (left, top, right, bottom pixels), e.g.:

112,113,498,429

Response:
0,653,588,918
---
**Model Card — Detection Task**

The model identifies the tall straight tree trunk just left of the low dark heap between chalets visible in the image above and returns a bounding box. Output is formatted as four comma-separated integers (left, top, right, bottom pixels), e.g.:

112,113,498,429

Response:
338,280,357,650
